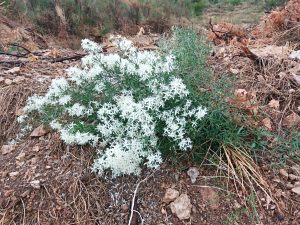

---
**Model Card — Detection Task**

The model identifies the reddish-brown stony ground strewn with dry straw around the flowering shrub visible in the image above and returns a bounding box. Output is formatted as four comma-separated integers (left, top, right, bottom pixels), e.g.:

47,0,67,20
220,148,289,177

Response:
0,1,300,225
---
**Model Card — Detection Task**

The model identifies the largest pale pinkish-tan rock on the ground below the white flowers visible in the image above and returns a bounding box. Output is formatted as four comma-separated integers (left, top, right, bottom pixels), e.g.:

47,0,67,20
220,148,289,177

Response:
170,194,193,220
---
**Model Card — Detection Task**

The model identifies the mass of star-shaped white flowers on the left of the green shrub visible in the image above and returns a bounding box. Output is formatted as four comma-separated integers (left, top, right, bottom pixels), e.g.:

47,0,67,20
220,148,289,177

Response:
18,37,206,176
